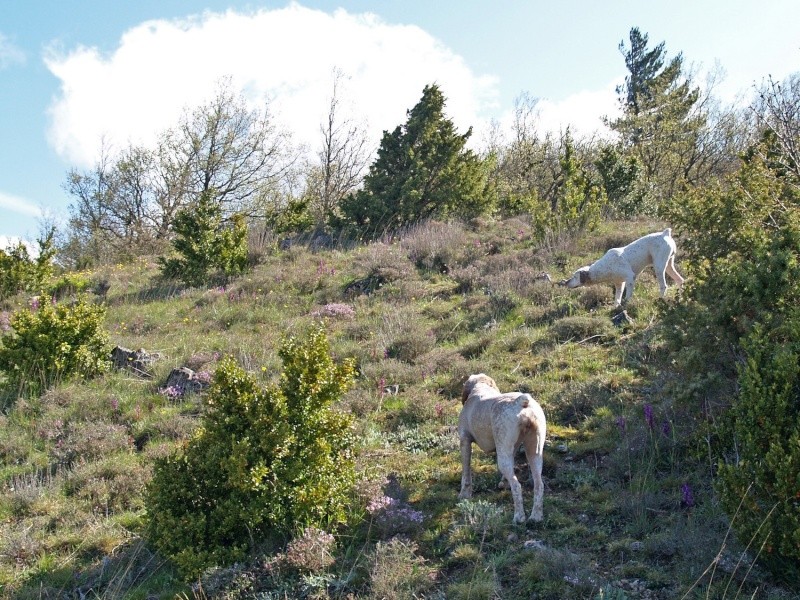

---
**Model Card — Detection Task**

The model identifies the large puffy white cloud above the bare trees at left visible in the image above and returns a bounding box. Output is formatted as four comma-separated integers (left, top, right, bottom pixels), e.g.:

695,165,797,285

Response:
46,3,497,166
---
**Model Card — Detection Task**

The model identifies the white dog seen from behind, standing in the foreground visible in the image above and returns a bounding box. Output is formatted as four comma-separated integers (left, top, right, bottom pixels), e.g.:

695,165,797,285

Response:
458,373,547,523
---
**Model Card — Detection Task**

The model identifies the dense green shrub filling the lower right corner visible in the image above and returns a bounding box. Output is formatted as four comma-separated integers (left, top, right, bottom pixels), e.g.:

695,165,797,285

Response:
717,316,800,582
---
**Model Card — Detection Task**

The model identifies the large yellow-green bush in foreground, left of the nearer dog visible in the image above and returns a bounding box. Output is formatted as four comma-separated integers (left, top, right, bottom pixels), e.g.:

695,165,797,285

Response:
146,330,355,577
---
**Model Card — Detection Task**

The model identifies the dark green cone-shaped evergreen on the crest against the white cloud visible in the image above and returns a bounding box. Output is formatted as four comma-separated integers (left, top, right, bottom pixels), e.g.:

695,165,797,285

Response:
342,85,493,235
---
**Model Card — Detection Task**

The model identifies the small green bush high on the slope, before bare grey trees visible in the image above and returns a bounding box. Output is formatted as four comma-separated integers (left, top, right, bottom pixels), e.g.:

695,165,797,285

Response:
159,193,247,286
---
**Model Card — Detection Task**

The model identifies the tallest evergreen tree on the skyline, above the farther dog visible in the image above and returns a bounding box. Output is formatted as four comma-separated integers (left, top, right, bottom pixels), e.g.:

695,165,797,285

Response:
609,27,705,212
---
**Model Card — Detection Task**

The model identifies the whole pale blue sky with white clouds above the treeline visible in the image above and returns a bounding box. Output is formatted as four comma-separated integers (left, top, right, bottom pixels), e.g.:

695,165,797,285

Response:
0,0,800,245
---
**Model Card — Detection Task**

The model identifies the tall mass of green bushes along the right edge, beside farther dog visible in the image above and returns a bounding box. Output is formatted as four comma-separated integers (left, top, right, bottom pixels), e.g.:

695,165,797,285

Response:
664,153,800,581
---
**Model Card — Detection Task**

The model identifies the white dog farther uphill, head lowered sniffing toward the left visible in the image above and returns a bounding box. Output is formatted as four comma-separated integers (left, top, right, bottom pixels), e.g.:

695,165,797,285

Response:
560,227,684,306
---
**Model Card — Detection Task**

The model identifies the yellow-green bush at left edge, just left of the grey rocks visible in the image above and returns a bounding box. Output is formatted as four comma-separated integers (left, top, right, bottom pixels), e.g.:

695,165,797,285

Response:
0,296,111,395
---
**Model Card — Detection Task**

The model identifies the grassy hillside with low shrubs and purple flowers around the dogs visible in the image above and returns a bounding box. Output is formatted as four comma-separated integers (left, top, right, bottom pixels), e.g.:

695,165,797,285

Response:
0,219,792,599
